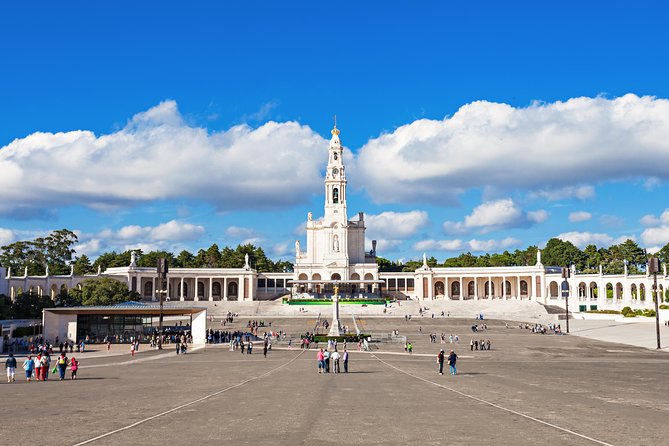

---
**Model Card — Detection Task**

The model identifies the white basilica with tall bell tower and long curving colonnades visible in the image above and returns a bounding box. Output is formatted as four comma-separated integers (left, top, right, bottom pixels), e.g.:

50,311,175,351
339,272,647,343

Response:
0,123,669,312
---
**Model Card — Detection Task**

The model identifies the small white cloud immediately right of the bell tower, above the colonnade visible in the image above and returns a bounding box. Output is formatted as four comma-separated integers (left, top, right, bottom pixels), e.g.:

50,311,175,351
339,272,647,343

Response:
365,210,429,240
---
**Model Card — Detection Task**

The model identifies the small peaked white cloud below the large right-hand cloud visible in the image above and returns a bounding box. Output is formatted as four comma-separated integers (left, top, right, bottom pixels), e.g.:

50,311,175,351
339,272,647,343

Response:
444,198,548,234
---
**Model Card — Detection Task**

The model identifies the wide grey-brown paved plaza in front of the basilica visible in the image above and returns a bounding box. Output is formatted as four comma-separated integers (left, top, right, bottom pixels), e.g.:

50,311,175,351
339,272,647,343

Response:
0,316,669,445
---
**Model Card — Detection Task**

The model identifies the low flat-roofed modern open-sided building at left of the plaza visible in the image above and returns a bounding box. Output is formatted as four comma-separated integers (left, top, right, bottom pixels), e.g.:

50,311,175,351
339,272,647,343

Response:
42,302,207,344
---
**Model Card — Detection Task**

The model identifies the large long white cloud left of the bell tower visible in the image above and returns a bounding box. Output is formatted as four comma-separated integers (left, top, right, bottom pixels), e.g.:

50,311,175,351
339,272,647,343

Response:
0,101,327,220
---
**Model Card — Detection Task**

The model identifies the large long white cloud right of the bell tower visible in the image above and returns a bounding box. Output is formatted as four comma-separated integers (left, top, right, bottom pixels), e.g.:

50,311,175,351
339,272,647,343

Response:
358,94,669,204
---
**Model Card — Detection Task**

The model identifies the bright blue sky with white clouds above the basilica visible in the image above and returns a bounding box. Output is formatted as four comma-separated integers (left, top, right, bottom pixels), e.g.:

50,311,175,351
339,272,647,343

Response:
0,0,669,261
